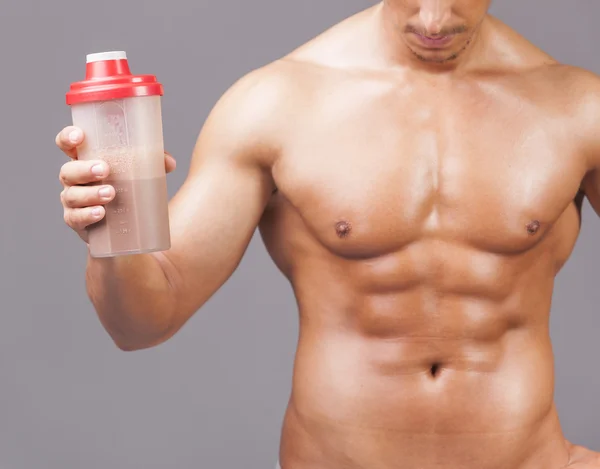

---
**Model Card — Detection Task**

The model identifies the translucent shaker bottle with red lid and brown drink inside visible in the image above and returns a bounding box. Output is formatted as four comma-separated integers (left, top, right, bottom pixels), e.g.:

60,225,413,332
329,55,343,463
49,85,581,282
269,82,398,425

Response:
66,51,171,257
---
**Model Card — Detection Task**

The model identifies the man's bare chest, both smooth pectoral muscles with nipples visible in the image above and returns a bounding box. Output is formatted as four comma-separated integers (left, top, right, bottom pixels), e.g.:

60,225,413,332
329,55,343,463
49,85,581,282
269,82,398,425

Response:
274,82,583,257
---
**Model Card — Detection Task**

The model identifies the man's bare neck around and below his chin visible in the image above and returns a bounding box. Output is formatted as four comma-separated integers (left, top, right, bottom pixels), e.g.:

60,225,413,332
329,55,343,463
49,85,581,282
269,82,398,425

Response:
374,2,490,74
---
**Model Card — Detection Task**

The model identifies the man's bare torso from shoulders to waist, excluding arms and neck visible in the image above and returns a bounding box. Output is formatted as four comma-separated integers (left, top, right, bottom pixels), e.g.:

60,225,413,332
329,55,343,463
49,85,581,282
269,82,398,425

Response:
261,3,600,469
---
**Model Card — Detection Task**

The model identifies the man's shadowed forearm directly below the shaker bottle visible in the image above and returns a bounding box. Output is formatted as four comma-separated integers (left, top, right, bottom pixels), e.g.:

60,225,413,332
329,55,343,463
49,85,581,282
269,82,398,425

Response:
86,253,176,350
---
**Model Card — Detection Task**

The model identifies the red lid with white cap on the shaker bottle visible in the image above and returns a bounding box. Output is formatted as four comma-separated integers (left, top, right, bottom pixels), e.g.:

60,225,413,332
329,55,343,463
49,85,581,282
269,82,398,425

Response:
67,51,163,105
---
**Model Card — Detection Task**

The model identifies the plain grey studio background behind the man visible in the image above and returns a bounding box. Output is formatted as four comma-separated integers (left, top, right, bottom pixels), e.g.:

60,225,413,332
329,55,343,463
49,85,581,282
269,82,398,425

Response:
0,0,600,469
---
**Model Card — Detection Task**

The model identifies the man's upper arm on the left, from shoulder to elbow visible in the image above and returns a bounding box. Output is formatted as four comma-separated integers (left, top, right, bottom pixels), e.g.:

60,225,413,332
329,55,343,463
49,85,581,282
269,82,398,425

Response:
159,65,286,330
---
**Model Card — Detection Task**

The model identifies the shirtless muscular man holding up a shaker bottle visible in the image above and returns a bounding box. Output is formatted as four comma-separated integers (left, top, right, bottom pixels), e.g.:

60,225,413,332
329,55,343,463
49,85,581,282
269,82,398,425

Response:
57,0,600,469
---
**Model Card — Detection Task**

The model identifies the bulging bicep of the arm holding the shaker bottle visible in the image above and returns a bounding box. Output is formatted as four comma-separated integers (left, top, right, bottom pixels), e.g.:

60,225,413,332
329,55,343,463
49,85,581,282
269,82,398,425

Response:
158,141,271,322
